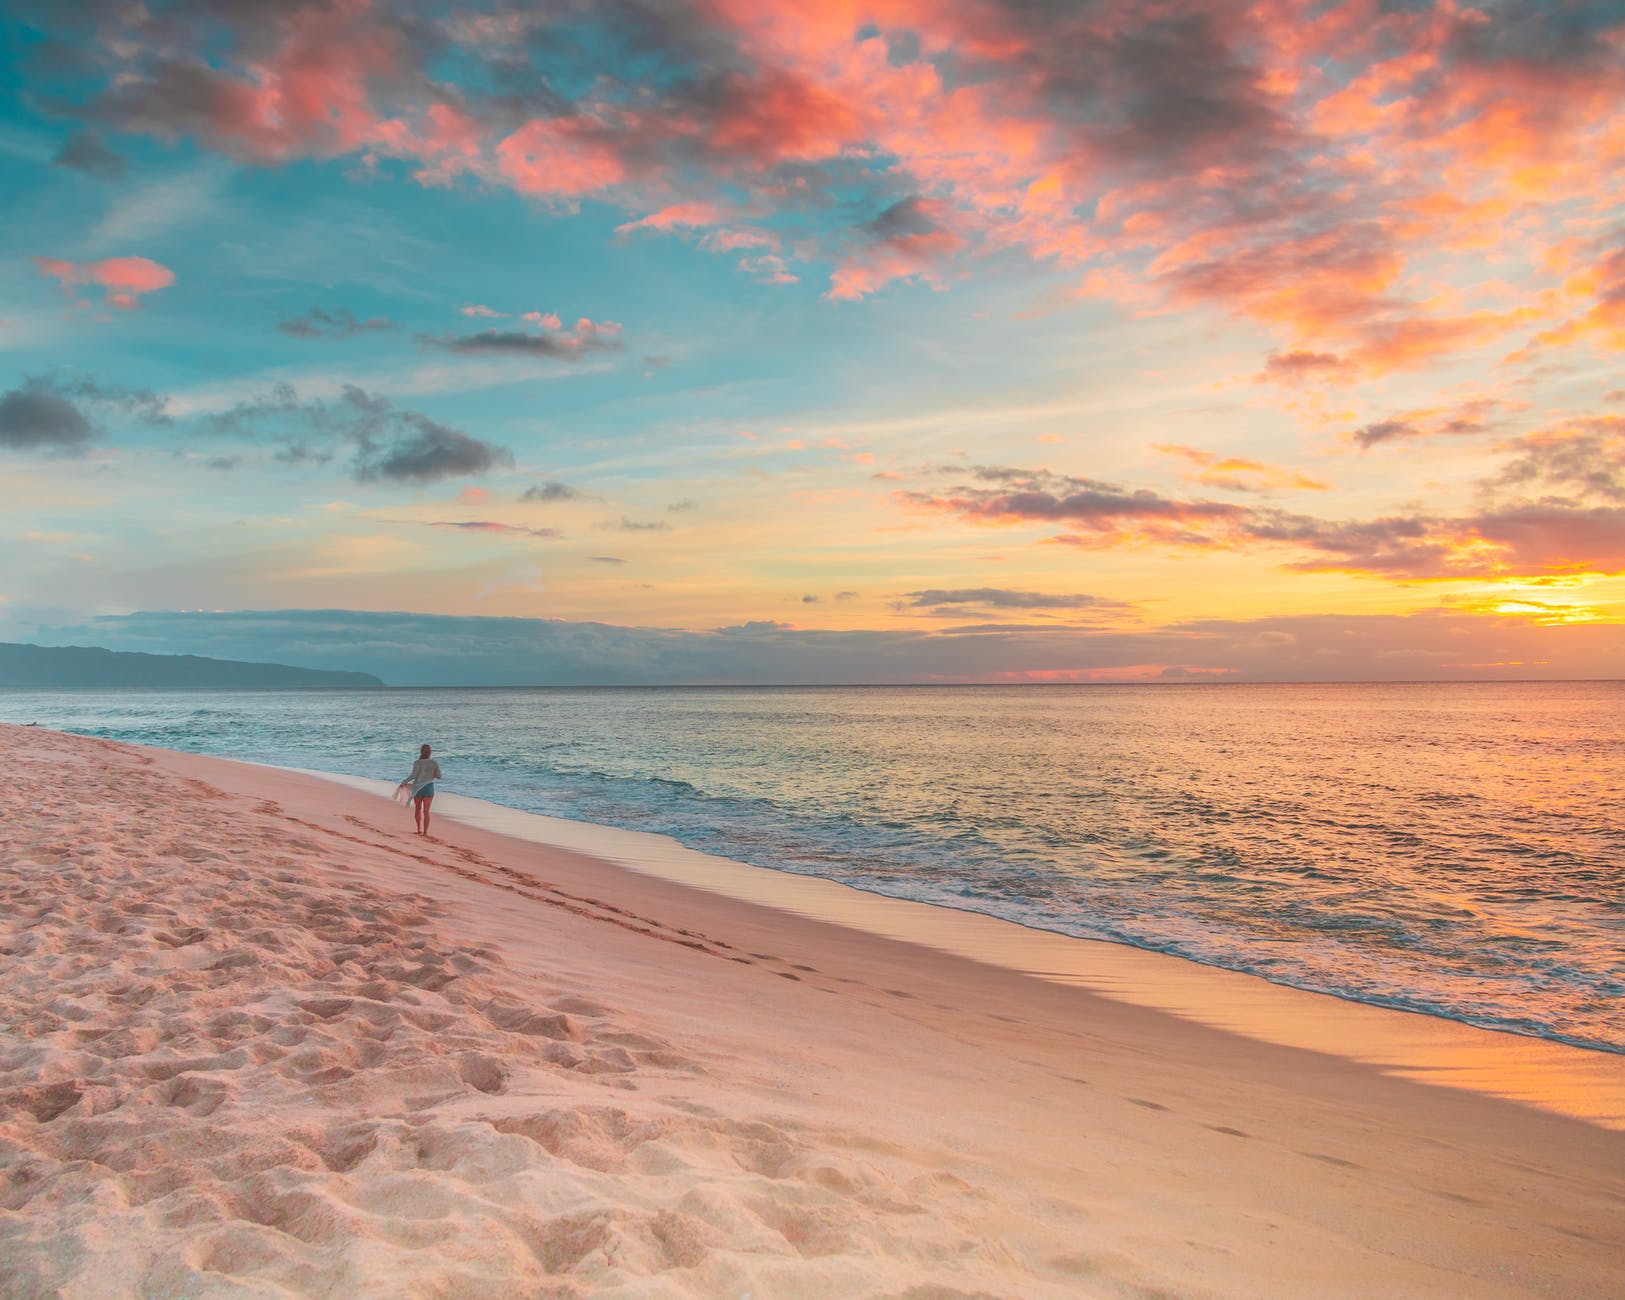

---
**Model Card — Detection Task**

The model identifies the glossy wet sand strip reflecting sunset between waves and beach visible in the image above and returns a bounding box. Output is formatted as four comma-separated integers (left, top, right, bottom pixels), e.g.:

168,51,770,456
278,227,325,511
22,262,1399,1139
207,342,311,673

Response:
289,764,1625,1131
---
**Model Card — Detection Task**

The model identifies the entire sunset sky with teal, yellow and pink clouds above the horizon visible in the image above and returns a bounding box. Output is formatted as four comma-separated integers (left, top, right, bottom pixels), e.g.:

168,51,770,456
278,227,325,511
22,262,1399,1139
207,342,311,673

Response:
0,0,1625,684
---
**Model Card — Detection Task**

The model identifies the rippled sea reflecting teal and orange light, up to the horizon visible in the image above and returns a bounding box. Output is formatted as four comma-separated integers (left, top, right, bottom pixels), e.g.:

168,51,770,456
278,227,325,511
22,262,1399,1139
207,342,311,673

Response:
0,683,1625,1051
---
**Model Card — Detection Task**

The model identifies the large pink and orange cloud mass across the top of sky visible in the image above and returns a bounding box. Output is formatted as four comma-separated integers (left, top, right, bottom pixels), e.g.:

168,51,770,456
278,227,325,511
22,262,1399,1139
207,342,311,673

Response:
66,0,1625,355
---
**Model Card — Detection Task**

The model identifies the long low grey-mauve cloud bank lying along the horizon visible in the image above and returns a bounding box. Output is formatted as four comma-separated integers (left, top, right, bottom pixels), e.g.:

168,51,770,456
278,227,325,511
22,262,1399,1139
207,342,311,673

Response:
15,609,1625,686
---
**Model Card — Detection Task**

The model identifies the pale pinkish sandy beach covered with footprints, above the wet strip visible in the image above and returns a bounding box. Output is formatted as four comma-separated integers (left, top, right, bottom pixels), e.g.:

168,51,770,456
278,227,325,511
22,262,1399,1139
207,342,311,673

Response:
0,726,1625,1300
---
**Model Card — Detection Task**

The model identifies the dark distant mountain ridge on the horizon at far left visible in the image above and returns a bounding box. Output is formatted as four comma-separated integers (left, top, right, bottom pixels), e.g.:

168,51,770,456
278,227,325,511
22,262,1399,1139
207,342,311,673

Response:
0,642,384,691
